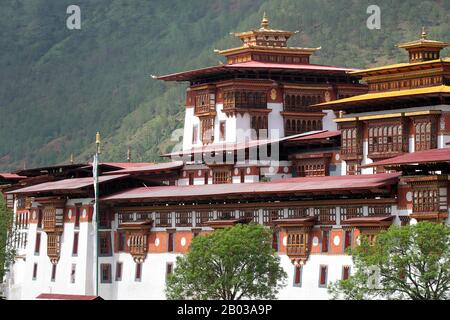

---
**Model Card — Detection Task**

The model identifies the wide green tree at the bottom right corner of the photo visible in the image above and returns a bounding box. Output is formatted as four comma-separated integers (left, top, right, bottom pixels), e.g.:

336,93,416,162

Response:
329,222,450,300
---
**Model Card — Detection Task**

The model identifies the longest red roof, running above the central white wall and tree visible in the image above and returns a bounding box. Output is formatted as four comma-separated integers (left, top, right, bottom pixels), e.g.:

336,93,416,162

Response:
102,173,400,201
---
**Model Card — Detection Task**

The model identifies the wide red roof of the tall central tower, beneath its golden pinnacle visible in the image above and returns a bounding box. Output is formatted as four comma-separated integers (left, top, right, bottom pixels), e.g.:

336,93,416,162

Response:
157,61,357,81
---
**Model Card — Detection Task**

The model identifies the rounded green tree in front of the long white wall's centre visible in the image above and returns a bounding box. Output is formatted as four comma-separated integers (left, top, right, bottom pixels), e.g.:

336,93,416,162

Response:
166,223,287,300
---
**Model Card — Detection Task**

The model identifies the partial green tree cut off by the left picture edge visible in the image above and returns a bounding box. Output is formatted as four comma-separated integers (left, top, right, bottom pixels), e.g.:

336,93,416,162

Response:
0,193,15,283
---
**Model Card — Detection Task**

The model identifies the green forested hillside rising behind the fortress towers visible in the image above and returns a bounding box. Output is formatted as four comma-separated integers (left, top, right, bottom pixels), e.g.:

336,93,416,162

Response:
0,0,450,170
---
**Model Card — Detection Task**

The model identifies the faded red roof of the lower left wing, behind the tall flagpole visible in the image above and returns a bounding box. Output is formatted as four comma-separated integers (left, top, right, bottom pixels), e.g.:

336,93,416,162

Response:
8,174,128,193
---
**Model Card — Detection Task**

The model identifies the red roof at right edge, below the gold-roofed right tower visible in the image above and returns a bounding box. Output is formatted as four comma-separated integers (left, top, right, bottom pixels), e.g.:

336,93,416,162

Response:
362,148,450,167
